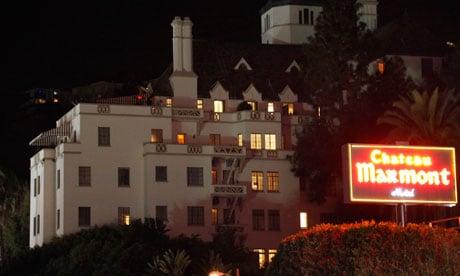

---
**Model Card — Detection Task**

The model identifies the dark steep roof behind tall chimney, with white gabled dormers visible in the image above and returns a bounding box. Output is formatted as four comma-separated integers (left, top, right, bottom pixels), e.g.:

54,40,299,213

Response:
151,40,309,101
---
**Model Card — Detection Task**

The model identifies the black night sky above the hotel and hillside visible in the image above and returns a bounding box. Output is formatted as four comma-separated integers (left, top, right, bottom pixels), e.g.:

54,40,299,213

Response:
0,0,460,92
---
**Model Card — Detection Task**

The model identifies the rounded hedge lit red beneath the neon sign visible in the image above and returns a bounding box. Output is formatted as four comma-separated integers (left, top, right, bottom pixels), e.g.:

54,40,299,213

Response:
267,222,460,275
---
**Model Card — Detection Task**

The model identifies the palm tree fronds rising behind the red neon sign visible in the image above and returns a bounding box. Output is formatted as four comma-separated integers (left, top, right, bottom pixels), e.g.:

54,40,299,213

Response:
377,89,460,147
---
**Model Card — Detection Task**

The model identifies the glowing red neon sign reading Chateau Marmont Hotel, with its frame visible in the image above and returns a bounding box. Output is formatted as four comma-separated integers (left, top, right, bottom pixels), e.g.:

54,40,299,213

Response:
342,144,457,205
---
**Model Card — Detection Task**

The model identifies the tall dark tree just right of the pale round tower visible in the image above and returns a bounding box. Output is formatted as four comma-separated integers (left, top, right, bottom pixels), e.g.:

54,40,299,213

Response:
305,0,374,107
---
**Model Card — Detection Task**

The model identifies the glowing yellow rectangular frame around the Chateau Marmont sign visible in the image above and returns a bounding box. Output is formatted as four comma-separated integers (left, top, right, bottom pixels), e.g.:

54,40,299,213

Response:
342,143,458,206
